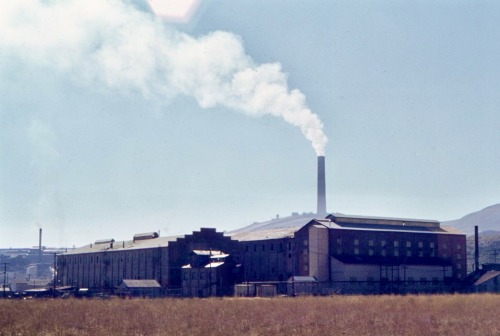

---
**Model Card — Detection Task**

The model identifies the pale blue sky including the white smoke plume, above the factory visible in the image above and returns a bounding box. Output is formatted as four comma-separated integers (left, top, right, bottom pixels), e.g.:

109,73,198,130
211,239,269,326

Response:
0,0,500,247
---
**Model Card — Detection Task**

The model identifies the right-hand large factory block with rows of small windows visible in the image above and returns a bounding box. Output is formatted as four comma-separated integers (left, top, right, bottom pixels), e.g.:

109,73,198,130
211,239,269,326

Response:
232,214,466,293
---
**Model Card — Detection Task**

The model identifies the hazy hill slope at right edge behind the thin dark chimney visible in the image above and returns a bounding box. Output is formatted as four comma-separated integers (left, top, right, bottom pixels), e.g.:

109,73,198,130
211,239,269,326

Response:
441,204,500,234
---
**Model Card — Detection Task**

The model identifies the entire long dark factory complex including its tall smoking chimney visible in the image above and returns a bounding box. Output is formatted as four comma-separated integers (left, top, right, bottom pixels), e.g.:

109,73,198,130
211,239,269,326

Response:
57,156,466,296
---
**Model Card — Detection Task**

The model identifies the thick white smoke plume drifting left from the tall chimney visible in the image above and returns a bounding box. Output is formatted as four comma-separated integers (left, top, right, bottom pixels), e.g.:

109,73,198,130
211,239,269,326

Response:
0,0,327,155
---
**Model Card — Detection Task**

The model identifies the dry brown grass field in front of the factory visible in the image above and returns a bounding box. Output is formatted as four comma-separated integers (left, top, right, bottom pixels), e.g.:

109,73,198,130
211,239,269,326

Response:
0,294,500,336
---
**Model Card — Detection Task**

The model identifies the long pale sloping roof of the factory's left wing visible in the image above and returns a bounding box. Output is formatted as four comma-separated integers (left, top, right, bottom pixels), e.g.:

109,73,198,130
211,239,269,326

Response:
62,236,184,255
